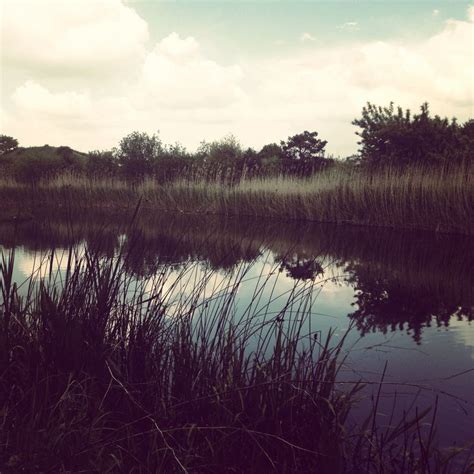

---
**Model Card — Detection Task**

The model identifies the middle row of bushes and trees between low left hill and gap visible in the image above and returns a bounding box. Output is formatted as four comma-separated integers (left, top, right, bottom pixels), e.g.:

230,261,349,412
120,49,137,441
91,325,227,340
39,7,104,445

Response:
87,131,333,182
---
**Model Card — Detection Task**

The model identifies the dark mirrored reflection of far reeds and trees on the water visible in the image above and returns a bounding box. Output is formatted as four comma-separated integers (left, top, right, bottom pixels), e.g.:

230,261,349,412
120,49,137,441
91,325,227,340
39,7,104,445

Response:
0,211,474,343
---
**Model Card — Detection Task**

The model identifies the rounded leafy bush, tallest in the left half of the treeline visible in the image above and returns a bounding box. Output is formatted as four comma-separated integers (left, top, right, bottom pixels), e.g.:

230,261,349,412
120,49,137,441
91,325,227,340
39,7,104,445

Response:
114,132,163,179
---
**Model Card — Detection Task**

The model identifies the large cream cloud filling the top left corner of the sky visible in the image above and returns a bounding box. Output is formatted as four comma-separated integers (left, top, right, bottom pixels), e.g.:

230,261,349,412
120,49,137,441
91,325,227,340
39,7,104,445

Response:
1,0,148,75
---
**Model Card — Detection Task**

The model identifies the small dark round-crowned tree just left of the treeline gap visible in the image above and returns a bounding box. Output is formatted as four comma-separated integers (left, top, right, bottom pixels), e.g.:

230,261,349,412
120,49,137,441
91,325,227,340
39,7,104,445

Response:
281,130,327,174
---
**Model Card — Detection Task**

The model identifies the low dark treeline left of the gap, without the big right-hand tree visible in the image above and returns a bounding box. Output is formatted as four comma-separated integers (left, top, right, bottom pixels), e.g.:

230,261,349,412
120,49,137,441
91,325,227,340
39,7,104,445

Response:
0,131,334,184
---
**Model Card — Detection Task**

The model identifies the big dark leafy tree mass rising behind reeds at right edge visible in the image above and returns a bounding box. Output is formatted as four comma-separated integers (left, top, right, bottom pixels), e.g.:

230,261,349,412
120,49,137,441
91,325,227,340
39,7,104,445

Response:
352,102,473,166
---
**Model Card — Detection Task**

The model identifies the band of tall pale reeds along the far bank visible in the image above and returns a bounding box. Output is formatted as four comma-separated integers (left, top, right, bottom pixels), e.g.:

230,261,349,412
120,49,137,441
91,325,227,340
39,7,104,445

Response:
0,164,474,234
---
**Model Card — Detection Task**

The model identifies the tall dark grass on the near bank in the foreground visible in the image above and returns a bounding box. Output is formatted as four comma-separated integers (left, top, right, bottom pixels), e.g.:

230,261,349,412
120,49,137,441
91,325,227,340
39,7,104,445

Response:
0,243,472,473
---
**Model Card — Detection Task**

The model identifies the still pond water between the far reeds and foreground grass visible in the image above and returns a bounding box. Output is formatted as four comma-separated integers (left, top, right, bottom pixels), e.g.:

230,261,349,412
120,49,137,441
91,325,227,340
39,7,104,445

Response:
0,210,474,445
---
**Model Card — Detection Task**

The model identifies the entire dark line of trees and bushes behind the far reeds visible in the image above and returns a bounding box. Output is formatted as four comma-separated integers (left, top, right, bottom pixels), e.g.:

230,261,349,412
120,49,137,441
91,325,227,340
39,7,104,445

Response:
0,103,474,182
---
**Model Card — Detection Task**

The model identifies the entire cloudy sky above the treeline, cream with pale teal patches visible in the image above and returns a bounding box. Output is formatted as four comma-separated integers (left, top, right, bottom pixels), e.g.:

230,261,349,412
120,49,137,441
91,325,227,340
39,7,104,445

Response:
0,0,474,156
